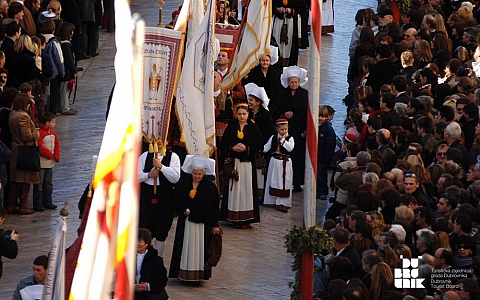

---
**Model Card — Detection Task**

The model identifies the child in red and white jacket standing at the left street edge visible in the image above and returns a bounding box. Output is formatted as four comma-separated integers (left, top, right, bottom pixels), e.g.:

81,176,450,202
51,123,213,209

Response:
33,112,60,211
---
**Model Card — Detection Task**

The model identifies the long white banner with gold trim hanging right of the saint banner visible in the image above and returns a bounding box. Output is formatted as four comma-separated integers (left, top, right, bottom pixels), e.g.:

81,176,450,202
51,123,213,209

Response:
176,0,217,157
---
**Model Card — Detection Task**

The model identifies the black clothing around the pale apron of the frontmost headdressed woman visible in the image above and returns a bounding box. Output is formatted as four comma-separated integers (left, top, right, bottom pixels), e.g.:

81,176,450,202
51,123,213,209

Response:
168,174,220,279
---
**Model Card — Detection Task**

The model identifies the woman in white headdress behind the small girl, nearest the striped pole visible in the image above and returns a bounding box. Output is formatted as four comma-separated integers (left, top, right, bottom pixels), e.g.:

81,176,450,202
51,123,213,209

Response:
269,66,308,192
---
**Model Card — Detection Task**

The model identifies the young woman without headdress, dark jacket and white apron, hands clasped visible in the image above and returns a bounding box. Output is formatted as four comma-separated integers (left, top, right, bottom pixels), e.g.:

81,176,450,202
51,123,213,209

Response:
220,103,262,229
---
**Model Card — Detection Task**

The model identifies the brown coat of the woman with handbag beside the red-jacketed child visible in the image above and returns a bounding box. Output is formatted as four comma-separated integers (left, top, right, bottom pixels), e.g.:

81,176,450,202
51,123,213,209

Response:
8,110,40,183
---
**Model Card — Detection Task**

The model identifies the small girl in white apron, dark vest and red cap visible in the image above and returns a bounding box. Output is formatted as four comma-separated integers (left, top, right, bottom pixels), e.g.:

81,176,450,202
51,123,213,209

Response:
263,118,295,213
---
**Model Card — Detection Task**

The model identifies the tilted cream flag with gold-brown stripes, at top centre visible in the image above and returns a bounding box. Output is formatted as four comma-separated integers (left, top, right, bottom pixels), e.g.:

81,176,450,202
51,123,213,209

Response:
222,0,272,90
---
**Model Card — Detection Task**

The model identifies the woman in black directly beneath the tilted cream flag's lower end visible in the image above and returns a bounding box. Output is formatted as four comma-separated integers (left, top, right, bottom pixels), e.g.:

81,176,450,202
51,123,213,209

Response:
243,46,282,99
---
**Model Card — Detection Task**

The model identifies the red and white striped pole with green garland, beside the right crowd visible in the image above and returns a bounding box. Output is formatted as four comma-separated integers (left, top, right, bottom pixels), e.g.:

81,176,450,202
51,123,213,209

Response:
300,0,322,300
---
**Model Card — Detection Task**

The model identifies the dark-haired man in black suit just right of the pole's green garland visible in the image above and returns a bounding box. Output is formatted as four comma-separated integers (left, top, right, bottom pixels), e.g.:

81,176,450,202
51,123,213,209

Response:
332,228,363,278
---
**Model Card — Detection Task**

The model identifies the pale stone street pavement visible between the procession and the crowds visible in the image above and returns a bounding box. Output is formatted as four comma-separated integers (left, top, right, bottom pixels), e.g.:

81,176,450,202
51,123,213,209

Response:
0,0,376,299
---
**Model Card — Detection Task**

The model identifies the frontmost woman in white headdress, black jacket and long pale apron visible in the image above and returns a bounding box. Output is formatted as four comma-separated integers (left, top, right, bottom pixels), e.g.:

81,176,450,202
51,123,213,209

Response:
169,155,220,282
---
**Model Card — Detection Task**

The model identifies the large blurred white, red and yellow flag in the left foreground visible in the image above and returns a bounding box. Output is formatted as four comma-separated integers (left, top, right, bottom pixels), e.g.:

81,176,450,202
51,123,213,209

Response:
69,0,145,300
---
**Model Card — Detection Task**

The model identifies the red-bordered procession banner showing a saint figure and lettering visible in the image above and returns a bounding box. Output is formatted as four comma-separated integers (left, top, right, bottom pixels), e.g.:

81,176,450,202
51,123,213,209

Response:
141,27,183,144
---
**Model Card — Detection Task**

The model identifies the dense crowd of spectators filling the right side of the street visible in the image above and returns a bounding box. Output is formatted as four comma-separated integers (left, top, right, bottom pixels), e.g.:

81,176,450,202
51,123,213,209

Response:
315,1,480,300
